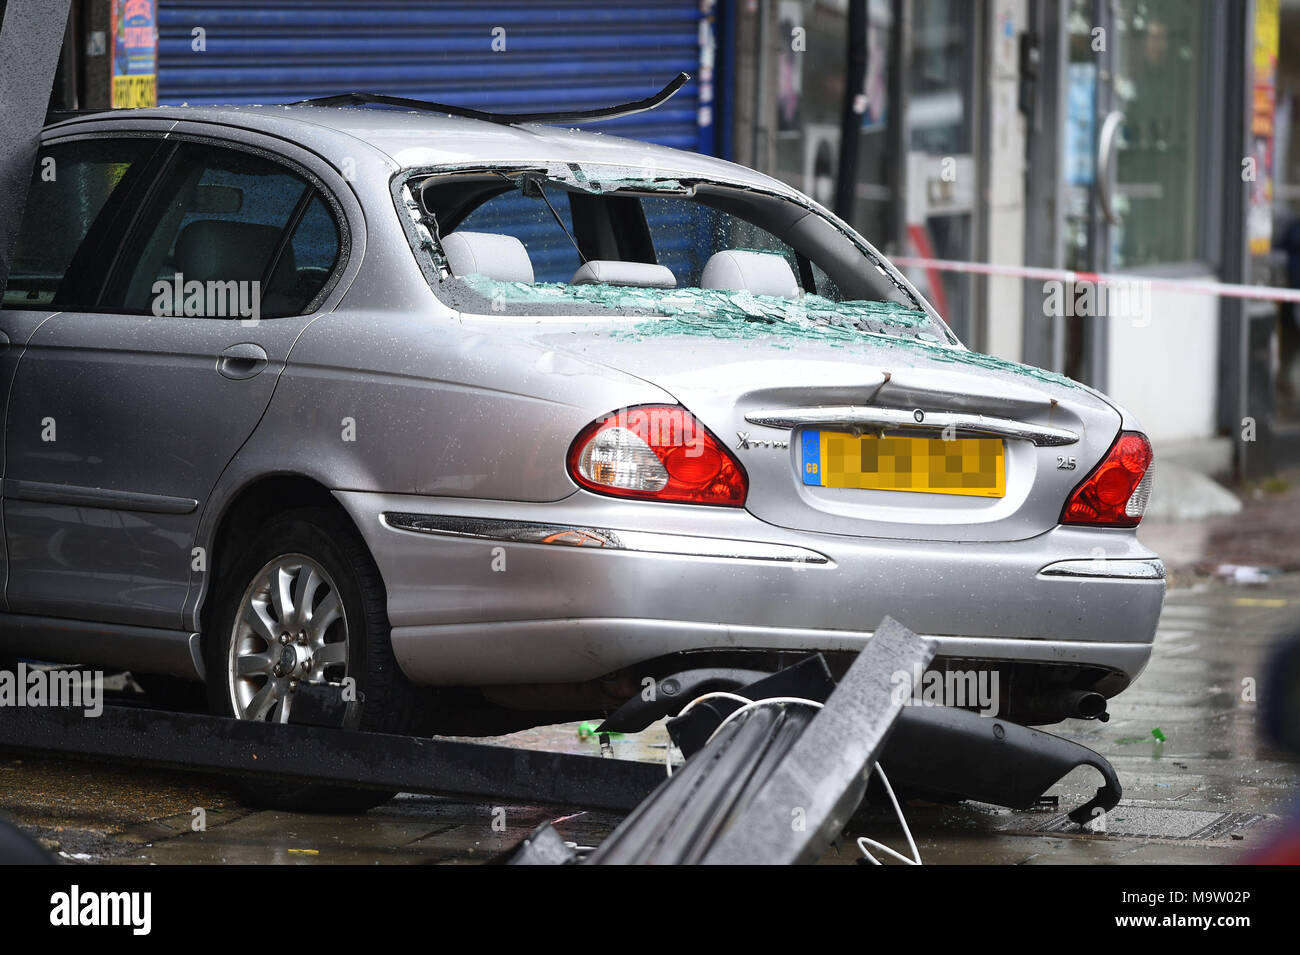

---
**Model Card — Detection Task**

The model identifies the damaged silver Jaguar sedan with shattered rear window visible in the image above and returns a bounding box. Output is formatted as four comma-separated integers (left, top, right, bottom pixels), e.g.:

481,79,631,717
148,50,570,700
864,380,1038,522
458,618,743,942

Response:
0,105,1165,799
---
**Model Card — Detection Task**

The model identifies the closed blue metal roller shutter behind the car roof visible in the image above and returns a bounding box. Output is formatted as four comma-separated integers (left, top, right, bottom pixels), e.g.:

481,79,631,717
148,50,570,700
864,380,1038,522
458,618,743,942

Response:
159,0,714,152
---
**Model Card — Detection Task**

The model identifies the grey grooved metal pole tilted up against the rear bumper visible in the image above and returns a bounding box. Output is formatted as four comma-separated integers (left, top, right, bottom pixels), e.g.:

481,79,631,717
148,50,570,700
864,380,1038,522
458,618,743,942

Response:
559,617,935,865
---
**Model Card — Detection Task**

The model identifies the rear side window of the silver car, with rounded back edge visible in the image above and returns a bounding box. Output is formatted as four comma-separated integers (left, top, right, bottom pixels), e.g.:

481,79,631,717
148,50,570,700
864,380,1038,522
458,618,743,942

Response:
103,143,339,318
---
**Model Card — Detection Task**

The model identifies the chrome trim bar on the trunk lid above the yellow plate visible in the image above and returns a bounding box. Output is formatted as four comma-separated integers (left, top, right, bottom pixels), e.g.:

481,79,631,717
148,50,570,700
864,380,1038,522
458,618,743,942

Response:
745,404,1079,447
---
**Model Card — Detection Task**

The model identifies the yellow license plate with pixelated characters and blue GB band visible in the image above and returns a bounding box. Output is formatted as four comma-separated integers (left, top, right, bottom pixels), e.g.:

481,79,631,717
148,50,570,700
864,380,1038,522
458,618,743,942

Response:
802,431,1006,498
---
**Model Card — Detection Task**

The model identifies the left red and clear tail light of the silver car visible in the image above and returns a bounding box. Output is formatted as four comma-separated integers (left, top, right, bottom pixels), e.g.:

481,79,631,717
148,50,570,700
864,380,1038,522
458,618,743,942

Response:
568,404,749,507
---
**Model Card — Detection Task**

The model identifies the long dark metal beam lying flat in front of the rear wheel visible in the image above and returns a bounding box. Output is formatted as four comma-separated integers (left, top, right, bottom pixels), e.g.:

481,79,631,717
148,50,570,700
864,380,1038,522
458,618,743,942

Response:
0,707,663,812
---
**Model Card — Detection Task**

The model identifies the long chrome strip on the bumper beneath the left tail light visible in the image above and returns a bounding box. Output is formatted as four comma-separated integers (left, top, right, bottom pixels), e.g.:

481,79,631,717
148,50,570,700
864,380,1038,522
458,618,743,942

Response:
381,511,831,564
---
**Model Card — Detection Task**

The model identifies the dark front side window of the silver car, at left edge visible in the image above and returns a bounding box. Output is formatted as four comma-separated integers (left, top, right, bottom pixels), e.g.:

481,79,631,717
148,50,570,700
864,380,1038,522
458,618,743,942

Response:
4,138,157,308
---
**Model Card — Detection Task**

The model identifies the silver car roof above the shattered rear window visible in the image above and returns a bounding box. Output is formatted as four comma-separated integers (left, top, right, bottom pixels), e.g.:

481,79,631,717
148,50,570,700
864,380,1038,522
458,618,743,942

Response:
49,105,792,194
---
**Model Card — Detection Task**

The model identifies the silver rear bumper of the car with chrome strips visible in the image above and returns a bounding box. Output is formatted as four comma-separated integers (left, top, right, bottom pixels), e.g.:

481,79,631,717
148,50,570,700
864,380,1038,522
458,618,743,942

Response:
335,491,1165,685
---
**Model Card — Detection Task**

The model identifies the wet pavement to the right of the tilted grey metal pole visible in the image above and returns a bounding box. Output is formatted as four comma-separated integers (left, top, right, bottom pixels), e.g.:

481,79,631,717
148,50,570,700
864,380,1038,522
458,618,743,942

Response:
852,574,1300,864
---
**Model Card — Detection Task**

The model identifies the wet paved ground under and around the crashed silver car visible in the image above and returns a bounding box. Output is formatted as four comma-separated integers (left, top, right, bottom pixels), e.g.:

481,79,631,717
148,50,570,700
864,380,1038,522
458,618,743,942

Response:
0,574,1300,864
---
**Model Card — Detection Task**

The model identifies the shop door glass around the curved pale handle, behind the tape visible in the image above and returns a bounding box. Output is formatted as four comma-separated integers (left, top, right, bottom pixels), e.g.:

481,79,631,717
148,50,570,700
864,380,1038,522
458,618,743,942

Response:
1062,0,1212,386
